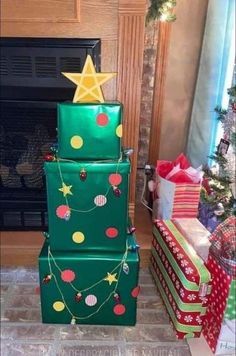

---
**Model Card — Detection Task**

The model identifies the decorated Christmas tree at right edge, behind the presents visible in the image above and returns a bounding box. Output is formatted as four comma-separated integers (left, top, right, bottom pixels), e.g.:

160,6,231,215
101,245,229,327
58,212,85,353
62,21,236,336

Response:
201,85,236,221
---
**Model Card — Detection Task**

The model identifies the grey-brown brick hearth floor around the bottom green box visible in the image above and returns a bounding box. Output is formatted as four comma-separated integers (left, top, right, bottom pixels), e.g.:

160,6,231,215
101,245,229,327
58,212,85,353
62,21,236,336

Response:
1,267,191,356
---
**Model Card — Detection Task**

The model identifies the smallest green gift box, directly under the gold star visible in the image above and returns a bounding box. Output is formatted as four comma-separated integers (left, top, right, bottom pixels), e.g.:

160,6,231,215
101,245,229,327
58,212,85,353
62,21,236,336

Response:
57,102,122,160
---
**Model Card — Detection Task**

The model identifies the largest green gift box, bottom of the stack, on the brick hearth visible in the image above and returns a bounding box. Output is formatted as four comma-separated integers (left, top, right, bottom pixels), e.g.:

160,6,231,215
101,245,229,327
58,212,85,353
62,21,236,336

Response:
39,236,139,325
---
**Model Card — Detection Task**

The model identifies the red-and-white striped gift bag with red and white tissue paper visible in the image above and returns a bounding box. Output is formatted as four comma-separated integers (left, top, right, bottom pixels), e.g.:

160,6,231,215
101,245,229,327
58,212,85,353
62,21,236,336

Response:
156,154,203,219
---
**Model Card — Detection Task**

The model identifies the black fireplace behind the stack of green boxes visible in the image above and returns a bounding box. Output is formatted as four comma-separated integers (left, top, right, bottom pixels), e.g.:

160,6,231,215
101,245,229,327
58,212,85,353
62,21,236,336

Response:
0,38,101,231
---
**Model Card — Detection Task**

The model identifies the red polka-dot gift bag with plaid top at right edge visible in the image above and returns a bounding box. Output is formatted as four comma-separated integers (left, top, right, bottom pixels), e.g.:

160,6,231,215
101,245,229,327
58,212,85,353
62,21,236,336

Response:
203,216,236,355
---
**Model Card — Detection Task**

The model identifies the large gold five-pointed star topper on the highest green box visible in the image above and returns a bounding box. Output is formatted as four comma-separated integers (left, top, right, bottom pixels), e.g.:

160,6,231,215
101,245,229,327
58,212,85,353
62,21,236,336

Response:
62,55,116,103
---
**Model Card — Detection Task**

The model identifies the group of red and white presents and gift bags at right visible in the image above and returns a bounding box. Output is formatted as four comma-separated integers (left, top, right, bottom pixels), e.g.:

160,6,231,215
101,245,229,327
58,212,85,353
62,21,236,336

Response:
150,154,236,355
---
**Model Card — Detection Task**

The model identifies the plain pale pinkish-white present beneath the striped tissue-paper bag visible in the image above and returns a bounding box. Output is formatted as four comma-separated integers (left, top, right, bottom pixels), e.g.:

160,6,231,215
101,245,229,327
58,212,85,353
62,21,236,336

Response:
174,218,211,261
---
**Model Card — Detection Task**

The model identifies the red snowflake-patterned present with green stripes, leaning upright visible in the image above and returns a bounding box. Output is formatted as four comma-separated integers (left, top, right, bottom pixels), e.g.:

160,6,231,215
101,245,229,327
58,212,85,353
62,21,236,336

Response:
150,220,211,339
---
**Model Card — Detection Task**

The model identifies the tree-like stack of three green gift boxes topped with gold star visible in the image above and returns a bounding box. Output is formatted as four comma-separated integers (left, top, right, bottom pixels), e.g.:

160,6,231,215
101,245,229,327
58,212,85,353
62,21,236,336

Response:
39,56,139,325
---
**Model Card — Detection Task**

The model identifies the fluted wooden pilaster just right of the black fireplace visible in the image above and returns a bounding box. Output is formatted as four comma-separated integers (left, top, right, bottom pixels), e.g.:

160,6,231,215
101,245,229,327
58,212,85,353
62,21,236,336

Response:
117,0,146,215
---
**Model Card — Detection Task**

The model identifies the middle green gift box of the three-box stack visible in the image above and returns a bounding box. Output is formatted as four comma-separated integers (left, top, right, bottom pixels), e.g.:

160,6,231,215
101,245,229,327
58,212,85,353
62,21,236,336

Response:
44,158,130,252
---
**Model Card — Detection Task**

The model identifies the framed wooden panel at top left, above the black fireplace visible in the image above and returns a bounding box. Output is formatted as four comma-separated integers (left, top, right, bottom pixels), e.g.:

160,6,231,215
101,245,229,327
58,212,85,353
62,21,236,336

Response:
1,0,80,22
